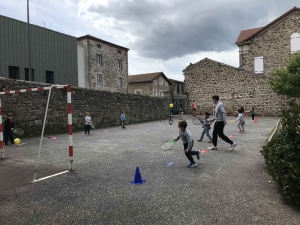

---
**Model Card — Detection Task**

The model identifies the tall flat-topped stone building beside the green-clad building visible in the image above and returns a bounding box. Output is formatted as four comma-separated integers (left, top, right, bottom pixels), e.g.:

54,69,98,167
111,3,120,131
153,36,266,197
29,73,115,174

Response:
77,35,129,93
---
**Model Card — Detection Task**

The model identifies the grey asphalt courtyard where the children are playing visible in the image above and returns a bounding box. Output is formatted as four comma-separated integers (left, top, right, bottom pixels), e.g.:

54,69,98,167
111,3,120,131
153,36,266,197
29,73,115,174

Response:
0,115,300,225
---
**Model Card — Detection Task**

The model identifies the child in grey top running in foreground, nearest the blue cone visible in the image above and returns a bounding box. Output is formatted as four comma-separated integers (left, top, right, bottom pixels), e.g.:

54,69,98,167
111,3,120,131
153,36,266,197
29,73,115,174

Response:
174,120,200,168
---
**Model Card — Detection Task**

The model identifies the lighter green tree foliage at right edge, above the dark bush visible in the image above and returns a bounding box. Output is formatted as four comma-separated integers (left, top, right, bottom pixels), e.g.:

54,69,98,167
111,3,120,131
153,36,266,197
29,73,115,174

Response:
270,51,300,98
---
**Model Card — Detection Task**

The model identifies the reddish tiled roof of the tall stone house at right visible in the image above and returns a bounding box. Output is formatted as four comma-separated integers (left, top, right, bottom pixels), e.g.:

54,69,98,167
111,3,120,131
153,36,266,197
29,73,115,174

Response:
236,7,300,44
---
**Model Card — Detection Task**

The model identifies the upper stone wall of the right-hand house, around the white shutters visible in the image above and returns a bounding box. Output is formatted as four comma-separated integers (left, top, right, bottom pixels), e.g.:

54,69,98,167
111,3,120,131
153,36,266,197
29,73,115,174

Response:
241,11,300,77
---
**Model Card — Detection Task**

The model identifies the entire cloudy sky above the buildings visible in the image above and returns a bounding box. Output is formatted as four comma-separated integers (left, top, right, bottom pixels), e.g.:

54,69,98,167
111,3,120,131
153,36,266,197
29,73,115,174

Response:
0,0,300,81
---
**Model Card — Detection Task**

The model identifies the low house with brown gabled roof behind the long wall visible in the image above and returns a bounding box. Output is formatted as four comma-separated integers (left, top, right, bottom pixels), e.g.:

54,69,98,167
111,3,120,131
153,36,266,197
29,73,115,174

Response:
128,72,172,97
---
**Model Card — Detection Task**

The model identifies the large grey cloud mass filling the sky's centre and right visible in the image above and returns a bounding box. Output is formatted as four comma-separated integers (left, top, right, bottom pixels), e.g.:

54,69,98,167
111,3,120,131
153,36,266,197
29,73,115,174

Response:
89,0,299,60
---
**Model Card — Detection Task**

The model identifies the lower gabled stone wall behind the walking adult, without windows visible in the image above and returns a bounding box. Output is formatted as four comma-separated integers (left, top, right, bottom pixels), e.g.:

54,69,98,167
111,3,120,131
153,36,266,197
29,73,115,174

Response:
184,58,284,116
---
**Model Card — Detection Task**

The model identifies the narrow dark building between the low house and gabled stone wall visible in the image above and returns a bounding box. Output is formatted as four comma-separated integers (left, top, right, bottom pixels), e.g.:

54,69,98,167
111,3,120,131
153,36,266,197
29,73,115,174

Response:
169,79,187,114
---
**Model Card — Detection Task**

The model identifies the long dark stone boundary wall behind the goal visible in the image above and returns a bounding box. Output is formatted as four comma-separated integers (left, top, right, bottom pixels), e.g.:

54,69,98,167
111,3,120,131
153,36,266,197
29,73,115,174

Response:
0,78,168,136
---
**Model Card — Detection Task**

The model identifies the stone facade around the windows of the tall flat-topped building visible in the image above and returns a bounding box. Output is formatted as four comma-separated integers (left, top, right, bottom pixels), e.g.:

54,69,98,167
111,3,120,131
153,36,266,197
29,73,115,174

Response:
78,39,128,93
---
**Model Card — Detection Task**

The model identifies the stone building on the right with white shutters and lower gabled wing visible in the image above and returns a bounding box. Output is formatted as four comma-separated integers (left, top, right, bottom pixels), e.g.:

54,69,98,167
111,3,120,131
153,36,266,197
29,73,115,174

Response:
183,7,300,116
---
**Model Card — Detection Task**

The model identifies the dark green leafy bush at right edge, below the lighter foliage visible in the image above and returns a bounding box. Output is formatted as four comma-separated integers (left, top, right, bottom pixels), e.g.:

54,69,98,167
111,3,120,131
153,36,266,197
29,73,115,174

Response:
262,101,300,204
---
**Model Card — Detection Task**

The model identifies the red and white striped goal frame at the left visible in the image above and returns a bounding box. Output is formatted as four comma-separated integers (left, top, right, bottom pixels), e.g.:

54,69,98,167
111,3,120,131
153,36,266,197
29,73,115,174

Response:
0,85,73,182
